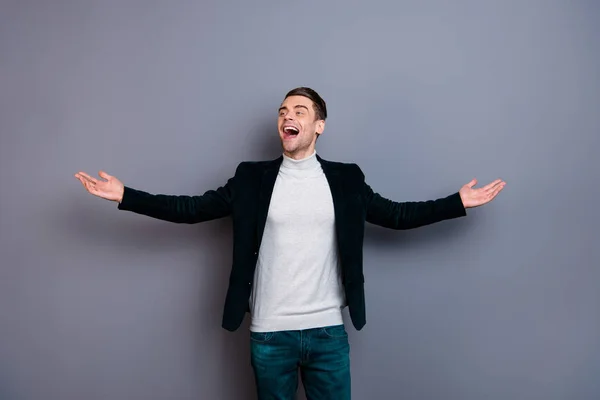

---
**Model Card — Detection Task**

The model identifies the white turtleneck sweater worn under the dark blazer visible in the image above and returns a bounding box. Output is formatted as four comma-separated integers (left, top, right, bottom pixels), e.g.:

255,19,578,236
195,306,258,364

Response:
250,153,345,332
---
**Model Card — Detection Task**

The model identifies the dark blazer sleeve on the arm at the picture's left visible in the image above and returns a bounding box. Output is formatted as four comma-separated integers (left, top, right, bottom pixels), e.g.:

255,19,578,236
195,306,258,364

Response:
118,176,235,224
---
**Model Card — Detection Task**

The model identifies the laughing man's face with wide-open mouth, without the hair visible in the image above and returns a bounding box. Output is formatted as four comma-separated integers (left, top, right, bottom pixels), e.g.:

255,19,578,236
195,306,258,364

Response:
277,96,325,159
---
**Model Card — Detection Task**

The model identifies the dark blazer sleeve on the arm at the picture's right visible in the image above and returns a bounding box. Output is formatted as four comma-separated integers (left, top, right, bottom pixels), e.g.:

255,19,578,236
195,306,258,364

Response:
363,183,466,230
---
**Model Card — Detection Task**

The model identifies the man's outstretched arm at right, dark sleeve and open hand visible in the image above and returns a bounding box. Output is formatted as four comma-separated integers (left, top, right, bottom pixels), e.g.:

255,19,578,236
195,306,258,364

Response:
364,179,505,230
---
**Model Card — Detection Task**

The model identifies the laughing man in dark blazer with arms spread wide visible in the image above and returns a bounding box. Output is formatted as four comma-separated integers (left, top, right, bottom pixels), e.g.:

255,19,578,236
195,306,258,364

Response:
75,87,505,400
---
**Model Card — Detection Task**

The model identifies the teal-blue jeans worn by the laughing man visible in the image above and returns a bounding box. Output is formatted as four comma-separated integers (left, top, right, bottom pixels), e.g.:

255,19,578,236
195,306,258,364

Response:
250,325,350,400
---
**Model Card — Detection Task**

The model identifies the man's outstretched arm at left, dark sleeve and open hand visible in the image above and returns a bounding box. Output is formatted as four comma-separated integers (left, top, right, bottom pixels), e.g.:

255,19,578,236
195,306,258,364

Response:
75,171,233,224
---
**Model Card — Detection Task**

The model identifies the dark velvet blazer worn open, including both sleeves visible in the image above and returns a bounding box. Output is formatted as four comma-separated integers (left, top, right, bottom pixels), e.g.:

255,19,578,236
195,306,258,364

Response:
118,156,466,331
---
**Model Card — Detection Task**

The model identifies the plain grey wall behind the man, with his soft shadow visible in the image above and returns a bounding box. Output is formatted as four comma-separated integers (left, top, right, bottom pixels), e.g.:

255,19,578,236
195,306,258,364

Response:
0,0,600,400
